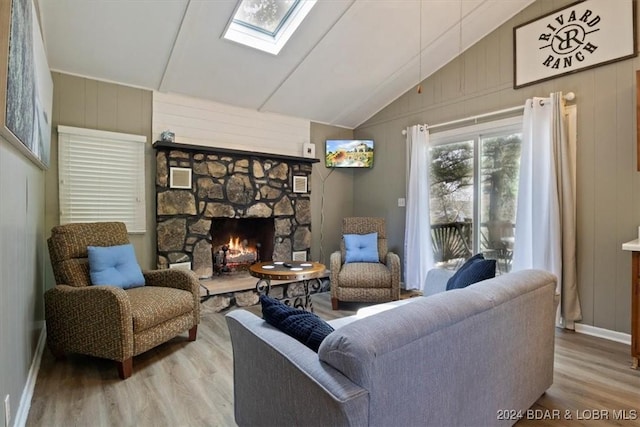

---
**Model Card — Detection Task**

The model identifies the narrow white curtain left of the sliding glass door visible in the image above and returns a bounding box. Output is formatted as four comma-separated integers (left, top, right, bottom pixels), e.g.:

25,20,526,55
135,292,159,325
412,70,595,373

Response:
404,125,433,289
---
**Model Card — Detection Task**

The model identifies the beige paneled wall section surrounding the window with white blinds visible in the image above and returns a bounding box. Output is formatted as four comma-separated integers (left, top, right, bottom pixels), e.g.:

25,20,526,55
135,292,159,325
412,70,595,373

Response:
45,73,156,288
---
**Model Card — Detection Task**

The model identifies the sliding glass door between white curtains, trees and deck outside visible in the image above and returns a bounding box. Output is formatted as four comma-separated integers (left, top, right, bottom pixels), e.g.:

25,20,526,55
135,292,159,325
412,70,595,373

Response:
429,117,522,273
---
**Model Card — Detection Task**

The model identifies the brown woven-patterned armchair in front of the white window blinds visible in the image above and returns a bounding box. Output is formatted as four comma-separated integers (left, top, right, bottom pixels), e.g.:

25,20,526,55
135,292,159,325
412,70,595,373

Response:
44,222,200,379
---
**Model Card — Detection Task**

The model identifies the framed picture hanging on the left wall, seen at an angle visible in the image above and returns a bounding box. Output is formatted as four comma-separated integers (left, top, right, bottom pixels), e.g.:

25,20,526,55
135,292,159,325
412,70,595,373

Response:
0,0,53,169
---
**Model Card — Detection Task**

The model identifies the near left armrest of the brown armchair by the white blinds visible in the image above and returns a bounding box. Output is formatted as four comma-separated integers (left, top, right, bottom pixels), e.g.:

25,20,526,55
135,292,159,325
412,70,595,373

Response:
44,285,133,361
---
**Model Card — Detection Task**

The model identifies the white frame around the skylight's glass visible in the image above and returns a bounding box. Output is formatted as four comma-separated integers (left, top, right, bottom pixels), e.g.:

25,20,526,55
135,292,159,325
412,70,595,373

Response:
223,0,317,55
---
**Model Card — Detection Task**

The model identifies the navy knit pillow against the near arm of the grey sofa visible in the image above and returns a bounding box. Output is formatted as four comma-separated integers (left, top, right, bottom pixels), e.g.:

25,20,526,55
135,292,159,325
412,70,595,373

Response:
260,295,334,352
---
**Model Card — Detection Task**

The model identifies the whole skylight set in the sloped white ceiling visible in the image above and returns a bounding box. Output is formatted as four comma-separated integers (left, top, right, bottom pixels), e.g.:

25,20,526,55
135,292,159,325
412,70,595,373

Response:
224,0,316,55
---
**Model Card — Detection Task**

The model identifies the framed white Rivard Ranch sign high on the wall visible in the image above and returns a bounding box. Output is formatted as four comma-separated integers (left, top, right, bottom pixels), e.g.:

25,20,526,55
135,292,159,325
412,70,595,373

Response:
513,0,637,89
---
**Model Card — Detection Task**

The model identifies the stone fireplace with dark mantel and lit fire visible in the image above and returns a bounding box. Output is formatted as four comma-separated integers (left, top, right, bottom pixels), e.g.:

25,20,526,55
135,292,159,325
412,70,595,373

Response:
153,141,318,278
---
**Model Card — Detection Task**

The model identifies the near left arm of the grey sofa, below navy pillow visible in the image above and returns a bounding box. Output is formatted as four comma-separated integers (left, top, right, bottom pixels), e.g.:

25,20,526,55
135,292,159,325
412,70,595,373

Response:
226,310,369,426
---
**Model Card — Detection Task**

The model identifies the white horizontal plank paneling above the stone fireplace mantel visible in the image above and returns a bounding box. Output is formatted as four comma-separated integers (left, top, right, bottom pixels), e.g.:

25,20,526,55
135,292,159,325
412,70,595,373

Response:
153,92,311,156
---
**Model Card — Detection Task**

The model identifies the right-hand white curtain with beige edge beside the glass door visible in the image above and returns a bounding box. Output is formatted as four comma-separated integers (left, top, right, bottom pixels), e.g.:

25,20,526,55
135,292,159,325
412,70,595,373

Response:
512,92,582,329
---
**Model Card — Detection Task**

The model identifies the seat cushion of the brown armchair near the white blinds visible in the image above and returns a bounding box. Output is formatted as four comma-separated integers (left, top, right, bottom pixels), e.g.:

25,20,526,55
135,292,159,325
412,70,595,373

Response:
127,286,193,334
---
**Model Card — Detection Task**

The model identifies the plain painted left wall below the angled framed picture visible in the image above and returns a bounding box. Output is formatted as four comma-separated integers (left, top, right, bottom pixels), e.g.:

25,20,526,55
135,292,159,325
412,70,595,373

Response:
0,138,46,423
